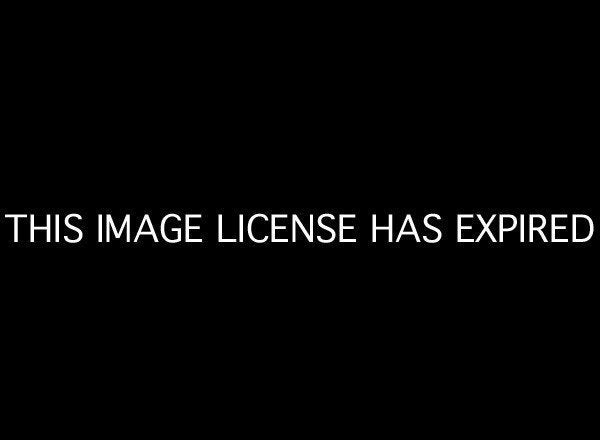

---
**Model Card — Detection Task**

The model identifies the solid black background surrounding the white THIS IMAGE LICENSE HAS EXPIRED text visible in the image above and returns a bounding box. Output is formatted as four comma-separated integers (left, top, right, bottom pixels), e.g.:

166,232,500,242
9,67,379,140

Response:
1,5,598,433
